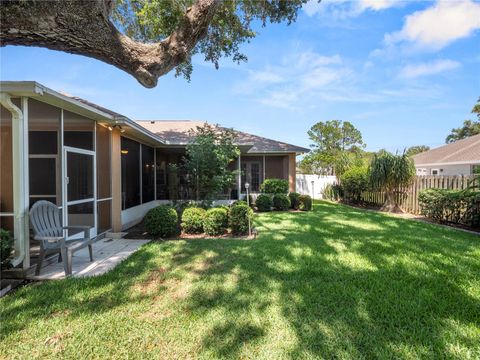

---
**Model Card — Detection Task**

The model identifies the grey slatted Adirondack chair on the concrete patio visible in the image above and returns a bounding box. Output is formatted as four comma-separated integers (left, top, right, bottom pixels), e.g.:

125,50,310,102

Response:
30,200,94,276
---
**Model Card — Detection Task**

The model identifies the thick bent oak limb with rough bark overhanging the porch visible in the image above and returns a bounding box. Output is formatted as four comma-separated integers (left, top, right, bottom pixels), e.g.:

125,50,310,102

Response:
0,0,220,88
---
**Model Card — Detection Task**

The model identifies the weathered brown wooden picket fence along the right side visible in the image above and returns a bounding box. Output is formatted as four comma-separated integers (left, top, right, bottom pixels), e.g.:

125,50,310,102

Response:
362,175,480,214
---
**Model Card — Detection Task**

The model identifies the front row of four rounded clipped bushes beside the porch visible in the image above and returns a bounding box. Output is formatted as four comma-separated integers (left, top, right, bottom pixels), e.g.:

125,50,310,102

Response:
144,201,253,238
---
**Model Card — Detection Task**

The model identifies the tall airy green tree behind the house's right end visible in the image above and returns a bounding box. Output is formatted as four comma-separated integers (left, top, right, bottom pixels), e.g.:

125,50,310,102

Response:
300,120,365,176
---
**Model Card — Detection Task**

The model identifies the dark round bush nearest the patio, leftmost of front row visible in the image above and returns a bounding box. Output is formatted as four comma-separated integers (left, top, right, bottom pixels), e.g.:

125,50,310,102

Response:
144,205,178,237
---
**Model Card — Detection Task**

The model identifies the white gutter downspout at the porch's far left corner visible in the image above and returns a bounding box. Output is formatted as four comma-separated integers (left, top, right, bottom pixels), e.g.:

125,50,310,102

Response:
0,93,30,269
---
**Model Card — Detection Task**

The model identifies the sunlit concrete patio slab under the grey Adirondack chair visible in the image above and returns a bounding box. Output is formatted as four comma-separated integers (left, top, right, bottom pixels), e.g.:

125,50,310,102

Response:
27,238,150,280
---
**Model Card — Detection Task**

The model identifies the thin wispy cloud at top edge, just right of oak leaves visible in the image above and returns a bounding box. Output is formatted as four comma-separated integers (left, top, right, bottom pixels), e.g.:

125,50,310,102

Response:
303,0,406,19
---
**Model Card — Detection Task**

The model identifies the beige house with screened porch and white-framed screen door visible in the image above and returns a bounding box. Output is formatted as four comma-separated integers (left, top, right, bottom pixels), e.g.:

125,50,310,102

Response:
0,81,308,269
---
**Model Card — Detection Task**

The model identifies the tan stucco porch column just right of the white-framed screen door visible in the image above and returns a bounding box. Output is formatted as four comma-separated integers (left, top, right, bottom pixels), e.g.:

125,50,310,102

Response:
110,128,122,232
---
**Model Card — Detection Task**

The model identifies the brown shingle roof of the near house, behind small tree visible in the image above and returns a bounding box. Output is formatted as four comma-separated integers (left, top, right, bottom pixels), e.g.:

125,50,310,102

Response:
137,120,309,153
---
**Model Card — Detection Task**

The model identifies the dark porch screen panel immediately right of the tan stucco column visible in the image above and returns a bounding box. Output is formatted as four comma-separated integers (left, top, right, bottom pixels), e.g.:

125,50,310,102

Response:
121,137,140,210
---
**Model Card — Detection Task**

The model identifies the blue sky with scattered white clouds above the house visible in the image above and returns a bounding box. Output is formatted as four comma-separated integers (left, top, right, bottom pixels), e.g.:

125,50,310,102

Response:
0,0,480,151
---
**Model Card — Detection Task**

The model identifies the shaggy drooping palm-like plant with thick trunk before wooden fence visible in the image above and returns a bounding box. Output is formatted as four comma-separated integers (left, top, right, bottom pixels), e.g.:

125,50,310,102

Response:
369,151,415,212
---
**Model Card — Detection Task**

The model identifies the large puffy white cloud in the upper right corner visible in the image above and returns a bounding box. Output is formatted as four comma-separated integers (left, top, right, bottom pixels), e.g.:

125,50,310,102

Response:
385,0,480,50
